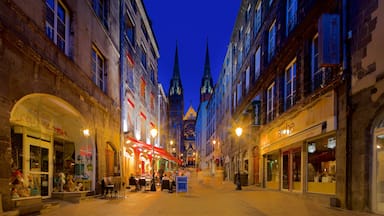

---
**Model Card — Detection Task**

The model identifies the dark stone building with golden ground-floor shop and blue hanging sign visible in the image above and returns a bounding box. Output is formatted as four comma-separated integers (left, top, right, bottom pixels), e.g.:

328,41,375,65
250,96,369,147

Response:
231,0,346,205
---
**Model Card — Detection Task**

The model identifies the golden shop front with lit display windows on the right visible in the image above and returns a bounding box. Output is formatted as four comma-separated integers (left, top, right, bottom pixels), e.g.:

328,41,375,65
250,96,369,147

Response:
260,92,336,195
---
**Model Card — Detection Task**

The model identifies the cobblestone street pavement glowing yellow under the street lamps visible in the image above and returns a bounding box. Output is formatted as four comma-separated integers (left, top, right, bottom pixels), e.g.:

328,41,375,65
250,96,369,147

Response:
41,174,374,216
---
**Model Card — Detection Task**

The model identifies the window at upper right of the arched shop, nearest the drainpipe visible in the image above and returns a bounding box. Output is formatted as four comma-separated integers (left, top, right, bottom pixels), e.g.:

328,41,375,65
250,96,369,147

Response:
91,47,106,92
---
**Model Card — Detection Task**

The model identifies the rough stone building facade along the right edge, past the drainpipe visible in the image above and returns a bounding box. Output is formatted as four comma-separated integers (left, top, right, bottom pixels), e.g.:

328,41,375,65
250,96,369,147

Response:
346,0,384,214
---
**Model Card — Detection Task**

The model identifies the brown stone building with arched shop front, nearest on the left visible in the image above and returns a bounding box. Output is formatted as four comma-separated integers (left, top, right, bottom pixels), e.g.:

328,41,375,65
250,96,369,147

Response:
0,0,120,210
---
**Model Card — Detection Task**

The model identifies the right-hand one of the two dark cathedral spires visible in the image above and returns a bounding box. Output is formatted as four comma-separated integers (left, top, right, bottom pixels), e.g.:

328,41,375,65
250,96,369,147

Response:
200,40,213,102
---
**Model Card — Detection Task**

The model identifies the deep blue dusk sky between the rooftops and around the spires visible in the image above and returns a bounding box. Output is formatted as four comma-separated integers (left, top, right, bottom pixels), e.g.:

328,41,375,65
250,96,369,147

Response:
144,0,241,112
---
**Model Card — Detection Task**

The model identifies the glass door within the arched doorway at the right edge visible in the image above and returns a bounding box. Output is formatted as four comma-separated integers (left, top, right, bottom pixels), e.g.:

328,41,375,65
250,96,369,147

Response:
373,128,384,213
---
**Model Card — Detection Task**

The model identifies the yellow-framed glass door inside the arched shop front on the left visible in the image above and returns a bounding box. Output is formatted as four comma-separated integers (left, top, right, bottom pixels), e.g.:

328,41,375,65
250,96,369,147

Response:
24,135,52,197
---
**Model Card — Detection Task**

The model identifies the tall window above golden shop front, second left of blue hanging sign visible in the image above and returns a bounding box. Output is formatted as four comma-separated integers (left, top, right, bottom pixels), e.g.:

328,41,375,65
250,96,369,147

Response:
284,59,296,110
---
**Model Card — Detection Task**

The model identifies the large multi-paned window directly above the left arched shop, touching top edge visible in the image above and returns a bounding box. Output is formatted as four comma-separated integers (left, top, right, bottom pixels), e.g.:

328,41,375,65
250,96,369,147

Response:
45,0,69,55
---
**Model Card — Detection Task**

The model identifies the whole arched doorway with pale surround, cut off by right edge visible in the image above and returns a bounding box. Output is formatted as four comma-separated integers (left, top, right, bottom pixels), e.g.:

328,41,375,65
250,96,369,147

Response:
371,120,384,214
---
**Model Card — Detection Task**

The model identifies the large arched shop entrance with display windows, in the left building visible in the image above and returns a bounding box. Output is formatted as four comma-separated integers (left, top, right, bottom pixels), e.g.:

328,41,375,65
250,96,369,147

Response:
10,94,96,197
